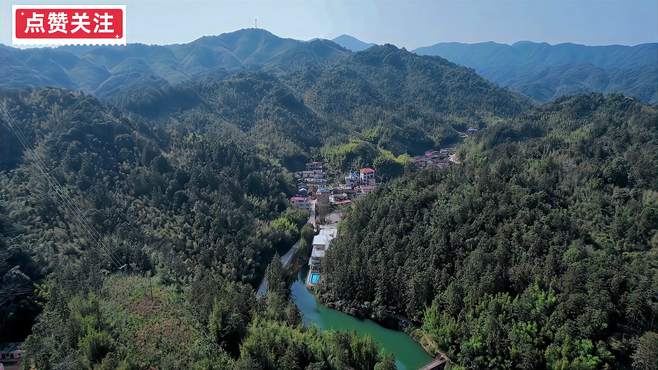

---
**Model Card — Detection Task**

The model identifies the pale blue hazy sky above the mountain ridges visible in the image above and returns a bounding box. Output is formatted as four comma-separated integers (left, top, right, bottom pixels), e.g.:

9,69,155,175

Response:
0,0,658,49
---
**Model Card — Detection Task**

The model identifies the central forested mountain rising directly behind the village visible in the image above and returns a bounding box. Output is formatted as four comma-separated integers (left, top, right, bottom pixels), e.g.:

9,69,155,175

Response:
125,45,530,170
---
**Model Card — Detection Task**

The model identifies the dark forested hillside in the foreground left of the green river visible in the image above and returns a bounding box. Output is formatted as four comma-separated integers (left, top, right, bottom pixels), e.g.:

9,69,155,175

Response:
0,89,400,369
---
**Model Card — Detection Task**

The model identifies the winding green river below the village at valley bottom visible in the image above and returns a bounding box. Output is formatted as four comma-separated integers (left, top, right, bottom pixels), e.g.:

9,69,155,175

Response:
291,269,432,370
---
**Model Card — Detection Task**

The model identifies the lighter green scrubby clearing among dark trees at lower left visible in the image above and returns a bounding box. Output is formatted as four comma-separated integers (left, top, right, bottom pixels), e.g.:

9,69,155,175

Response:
25,276,231,369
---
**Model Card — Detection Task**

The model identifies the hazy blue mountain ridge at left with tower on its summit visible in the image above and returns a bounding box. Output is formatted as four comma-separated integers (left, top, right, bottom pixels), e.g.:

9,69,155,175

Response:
0,28,349,98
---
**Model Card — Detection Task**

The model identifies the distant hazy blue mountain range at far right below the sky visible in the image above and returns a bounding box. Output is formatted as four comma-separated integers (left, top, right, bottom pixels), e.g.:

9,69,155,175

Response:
414,41,658,104
